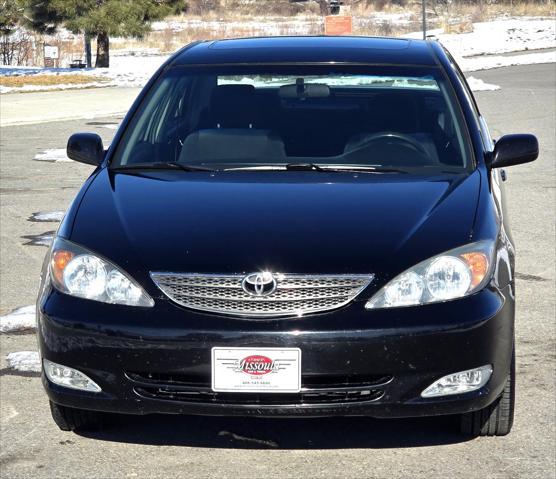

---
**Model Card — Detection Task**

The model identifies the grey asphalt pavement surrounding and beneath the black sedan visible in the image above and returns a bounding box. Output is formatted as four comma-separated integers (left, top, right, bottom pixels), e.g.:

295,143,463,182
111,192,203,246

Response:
0,64,556,478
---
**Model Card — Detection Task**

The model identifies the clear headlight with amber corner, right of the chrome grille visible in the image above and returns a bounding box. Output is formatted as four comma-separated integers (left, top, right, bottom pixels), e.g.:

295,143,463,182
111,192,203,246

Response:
365,241,494,309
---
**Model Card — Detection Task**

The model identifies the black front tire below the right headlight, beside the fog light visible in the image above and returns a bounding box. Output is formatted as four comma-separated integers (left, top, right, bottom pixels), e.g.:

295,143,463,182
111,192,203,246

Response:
460,349,515,437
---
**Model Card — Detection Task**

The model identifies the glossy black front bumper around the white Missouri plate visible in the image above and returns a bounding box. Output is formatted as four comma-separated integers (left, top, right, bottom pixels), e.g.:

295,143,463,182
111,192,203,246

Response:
38,287,514,417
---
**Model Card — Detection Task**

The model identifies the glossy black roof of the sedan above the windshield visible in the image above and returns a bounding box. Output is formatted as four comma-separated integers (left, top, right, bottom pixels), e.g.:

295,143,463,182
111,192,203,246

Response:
171,36,437,66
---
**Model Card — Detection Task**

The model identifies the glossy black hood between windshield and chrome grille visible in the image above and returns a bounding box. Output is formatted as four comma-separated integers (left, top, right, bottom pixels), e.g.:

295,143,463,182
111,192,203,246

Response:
67,169,480,279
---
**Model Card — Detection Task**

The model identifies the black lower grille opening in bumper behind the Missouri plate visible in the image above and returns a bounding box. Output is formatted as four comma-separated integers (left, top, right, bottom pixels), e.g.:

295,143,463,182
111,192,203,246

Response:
126,373,393,406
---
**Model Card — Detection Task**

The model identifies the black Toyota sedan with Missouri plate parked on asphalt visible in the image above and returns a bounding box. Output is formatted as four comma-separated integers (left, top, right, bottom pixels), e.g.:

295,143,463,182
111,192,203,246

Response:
37,37,538,435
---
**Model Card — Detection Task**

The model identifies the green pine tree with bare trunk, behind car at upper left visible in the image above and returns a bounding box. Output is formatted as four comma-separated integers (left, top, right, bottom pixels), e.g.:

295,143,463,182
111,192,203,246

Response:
23,0,186,67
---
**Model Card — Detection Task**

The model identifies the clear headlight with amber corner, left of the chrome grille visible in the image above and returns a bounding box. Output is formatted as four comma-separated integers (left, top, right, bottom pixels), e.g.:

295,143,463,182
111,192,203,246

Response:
49,238,154,307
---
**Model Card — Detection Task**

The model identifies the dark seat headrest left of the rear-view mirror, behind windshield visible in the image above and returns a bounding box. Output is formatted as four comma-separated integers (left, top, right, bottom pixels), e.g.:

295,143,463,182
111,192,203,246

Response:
210,85,260,128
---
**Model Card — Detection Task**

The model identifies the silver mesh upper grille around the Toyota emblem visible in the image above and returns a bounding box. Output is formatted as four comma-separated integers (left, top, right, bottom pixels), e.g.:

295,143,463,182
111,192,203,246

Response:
151,273,373,317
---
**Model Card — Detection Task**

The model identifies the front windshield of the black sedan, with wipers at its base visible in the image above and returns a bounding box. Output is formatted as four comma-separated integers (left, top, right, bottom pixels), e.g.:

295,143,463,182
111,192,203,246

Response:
111,65,471,174
